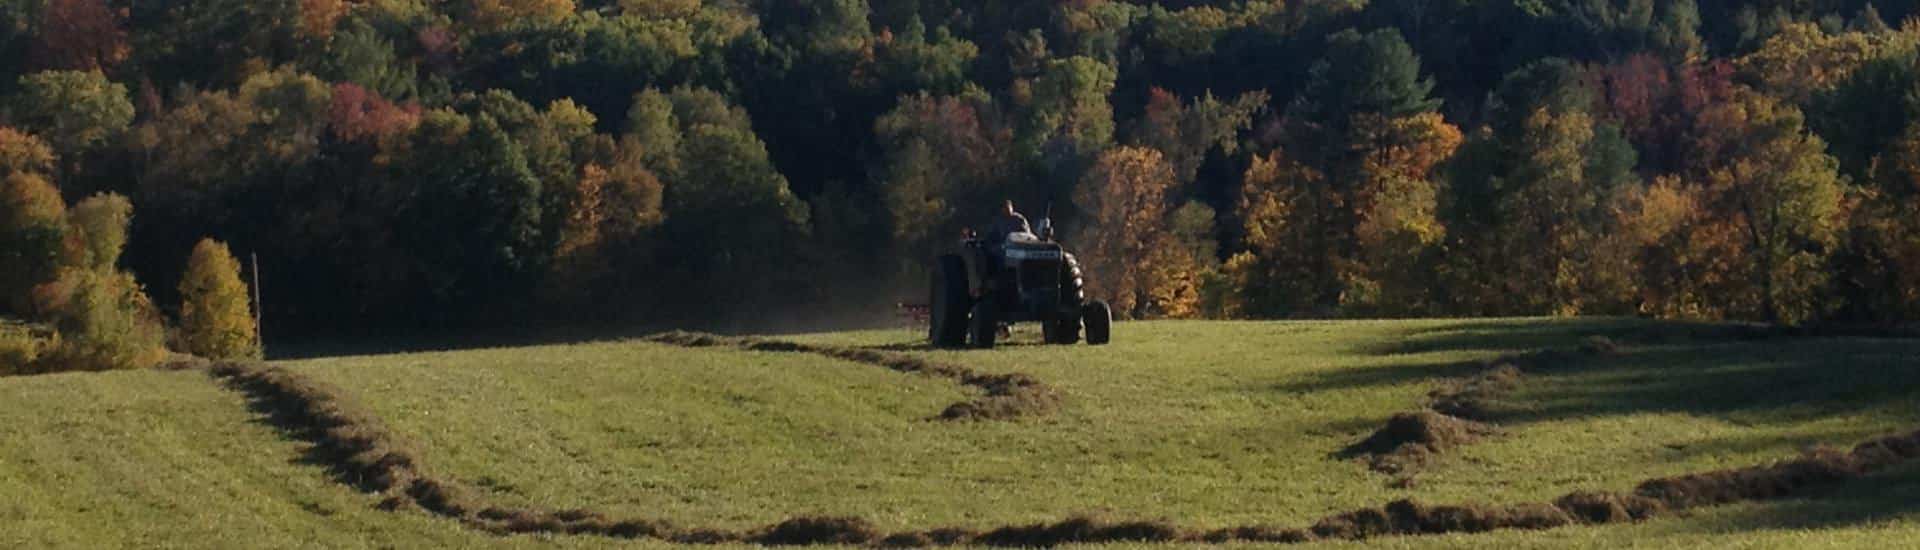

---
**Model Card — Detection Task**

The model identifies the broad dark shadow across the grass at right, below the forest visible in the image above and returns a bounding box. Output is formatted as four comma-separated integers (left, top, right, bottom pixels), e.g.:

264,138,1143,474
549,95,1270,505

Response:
1269,319,1920,423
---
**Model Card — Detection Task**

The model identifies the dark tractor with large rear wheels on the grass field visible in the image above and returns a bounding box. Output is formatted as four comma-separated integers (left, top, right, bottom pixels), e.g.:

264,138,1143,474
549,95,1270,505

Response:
927,219,1114,348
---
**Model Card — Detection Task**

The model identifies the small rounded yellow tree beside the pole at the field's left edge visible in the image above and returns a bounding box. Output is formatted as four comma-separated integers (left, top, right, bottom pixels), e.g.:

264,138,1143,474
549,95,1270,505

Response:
180,238,259,360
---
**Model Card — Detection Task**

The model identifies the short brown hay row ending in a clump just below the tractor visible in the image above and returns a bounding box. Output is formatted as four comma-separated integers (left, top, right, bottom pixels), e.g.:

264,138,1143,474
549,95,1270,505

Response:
641,331,1060,421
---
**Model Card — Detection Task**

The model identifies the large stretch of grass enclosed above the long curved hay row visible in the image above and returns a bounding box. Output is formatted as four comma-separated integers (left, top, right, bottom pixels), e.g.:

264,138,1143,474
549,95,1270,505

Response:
292,319,1920,544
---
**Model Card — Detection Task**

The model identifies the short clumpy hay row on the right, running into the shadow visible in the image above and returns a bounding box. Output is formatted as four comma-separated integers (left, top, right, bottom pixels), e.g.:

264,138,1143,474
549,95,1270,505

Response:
1334,337,1619,475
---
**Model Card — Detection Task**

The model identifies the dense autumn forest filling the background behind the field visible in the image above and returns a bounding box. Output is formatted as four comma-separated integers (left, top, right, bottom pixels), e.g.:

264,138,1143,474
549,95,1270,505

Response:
0,0,1920,351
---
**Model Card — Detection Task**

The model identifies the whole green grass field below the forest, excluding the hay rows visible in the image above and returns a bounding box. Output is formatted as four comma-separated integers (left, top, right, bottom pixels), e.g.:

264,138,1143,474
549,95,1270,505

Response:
0,319,1920,548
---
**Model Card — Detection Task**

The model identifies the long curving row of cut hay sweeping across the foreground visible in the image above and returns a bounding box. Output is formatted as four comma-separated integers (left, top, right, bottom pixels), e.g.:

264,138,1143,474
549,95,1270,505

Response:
209,344,1920,546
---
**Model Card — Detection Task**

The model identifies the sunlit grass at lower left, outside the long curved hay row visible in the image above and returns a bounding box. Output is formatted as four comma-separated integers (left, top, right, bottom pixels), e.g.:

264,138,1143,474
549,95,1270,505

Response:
0,365,660,548
